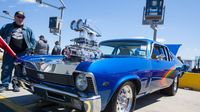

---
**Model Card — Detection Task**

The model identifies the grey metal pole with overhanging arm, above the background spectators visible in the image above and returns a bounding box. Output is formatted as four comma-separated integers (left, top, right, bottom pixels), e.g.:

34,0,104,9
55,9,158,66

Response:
36,0,66,44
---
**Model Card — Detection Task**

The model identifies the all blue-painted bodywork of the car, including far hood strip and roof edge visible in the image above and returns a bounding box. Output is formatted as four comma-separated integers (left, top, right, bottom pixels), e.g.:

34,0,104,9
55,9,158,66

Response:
18,39,182,110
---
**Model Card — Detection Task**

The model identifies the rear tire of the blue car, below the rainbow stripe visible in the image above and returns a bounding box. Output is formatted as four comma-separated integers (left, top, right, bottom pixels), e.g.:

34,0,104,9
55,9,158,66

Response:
161,76,179,96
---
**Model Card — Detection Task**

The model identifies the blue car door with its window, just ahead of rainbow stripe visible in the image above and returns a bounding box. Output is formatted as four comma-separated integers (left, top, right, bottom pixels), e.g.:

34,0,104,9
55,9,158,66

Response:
150,44,171,92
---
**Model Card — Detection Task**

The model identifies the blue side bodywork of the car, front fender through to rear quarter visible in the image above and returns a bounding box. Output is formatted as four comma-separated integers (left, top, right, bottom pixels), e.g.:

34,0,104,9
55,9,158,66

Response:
77,40,181,109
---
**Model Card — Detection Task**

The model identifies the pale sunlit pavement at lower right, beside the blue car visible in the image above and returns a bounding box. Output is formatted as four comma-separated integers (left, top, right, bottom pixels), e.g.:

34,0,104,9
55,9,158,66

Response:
136,89,200,112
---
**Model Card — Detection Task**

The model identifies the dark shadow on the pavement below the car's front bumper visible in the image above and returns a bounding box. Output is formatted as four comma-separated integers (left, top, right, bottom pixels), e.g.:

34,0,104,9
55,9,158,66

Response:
0,94,76,112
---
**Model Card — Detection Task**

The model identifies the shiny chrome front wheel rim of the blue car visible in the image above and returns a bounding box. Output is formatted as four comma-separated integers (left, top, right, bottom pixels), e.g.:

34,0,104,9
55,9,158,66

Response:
116,85,133,112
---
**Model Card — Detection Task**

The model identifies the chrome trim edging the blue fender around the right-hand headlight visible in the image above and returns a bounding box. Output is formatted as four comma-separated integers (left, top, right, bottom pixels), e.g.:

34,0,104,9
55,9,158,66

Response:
74,70,98,95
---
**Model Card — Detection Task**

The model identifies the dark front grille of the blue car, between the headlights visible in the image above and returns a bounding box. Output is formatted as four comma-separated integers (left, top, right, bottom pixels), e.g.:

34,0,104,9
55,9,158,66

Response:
26,68,74,86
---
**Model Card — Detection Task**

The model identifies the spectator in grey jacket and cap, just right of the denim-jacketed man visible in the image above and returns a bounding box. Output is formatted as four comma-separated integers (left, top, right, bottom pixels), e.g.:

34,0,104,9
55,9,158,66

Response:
35,35,49,55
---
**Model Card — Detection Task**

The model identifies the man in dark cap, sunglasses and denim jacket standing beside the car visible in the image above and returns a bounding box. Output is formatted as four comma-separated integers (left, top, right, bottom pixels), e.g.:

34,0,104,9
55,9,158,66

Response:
0,11,36,92
